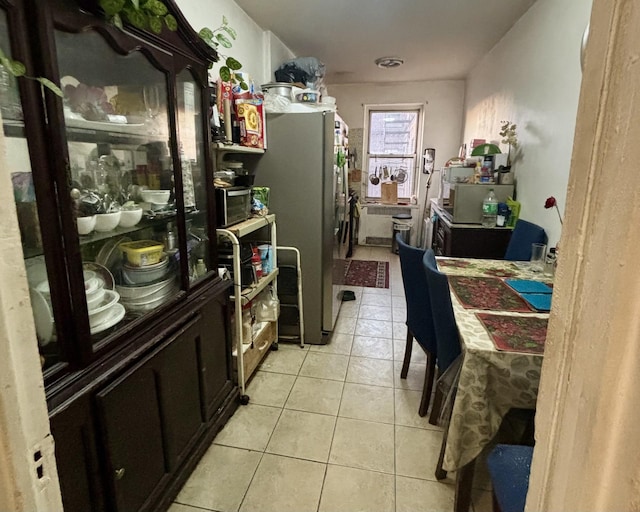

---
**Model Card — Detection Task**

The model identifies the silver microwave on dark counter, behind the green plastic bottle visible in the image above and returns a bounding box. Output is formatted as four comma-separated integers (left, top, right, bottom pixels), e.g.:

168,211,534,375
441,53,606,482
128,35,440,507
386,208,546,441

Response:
443,183,514,224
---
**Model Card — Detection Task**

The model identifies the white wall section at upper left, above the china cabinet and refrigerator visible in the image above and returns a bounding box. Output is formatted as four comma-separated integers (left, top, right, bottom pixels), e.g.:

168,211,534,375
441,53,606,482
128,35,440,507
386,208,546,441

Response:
177,0,293,86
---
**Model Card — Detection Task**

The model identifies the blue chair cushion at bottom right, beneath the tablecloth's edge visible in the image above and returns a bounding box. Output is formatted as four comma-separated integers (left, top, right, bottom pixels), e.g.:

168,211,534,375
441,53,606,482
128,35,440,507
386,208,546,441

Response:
487,444,533,512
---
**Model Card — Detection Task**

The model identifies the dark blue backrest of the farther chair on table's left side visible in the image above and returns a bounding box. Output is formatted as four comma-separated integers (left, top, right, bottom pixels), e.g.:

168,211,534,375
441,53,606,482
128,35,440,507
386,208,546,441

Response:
396,234,437,354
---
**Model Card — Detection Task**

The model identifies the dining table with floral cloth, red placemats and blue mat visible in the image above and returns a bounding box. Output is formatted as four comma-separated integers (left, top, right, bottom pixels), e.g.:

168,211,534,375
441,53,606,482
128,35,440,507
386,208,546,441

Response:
437,257,553,512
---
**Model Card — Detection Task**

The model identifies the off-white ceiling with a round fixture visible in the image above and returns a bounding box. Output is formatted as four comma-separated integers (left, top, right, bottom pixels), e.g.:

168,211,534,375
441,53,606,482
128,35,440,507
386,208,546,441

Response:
235,0,535,84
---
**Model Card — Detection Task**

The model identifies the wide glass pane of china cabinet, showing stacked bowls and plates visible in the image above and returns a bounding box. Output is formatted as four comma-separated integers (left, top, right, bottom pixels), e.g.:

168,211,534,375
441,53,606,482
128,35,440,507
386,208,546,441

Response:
56,32,181,342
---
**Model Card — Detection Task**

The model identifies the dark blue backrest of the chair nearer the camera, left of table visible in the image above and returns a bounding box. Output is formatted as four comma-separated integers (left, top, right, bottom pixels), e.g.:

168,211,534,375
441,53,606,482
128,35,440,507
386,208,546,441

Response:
422,249,461,372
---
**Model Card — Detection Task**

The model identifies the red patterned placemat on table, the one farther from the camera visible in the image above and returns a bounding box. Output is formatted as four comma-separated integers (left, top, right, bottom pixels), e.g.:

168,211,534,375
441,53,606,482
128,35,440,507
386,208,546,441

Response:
449,276,531,313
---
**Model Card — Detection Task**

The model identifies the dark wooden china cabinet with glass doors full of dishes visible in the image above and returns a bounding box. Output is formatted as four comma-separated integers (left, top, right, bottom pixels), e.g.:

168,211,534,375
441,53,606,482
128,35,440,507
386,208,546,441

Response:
0,0,238,511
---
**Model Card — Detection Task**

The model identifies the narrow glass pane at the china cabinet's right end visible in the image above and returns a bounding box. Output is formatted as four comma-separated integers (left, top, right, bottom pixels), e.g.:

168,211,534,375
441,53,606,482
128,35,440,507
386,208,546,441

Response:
177,70,212,283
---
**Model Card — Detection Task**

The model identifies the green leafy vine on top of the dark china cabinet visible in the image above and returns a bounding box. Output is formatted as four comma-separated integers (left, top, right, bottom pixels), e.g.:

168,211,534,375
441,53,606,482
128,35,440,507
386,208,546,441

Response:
99,0,178,34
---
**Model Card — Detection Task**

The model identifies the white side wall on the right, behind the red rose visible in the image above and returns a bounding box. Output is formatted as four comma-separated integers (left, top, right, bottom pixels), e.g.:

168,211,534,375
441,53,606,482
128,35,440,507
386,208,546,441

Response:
464,0,591,245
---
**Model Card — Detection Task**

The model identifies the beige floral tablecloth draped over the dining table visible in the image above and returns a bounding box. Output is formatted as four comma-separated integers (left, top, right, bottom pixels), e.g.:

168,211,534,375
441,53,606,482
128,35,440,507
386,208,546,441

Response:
438,258,552,471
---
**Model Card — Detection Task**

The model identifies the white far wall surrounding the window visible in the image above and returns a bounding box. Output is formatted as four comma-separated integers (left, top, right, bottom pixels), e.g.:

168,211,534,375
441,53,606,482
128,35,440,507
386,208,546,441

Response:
327,80,465,243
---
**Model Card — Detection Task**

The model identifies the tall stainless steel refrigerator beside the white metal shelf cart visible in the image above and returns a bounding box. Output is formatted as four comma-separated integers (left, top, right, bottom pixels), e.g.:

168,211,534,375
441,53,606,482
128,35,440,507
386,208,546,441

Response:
254,112,348,344
